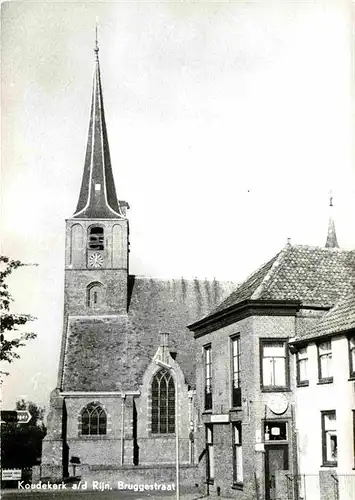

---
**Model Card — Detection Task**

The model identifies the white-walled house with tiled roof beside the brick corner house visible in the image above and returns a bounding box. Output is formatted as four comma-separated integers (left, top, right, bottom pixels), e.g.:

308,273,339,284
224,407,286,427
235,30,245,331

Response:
291,288,355,500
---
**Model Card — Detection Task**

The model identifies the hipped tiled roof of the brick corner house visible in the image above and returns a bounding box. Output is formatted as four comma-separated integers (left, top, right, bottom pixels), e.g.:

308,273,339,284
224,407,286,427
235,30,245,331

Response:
213,245,355,313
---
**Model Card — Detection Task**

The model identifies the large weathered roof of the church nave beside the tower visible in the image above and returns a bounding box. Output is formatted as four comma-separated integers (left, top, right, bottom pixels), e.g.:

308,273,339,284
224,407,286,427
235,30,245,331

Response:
62,276,236,391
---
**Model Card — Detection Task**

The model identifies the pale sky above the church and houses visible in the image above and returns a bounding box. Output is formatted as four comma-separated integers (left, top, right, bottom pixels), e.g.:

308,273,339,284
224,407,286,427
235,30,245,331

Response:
1,0,355,409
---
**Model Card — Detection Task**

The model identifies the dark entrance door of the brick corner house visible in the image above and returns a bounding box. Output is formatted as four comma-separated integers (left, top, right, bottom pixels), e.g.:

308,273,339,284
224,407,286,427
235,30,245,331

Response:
265,444,288,500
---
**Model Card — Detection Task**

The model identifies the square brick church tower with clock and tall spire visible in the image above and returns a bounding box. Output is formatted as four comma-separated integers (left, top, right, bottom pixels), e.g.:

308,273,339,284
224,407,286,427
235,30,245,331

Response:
65,40,129,317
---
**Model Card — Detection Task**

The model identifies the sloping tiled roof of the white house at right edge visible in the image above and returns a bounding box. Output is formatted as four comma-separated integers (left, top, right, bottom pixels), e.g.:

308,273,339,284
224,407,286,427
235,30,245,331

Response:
296,288,355,343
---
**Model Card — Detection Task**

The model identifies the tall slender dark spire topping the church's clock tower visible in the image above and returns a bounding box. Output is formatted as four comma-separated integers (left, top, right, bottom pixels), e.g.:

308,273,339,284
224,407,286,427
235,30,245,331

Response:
73,23,124,219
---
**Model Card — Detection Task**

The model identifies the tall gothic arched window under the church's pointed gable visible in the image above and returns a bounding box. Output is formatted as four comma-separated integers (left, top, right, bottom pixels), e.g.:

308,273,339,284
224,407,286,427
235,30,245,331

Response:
152,369,175,434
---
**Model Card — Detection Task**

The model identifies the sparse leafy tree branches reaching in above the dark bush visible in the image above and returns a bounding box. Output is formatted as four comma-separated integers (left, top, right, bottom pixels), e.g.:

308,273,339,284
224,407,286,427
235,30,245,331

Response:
0,256,36,375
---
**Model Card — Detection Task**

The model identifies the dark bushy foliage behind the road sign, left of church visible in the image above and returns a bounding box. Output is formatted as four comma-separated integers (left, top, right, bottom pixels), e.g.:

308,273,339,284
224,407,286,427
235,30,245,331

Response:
1,399,46,469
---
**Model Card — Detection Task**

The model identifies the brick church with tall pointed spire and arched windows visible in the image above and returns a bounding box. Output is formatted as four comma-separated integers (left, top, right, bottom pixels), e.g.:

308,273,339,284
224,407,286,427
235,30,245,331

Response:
38,42,235,484
